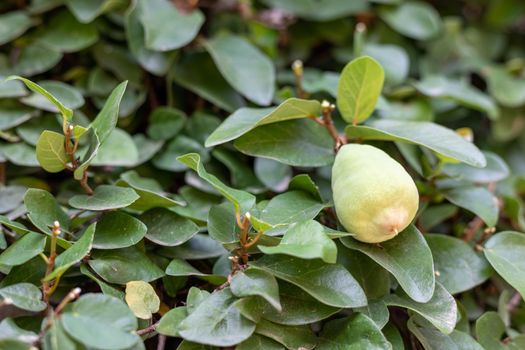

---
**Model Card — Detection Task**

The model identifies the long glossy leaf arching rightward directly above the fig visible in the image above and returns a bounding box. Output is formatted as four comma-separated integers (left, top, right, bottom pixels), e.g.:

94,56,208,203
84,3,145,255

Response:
345,120,486,167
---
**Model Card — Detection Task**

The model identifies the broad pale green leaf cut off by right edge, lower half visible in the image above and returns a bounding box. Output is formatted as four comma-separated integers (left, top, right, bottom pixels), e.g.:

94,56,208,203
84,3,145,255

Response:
483,231,525,297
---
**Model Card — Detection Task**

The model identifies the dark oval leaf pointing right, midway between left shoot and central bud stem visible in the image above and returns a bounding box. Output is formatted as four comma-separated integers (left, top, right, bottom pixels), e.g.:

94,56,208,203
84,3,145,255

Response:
140,208,199,247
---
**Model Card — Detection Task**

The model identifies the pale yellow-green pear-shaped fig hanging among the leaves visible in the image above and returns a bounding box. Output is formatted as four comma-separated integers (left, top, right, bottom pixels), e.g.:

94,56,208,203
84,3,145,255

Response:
332,144,419,243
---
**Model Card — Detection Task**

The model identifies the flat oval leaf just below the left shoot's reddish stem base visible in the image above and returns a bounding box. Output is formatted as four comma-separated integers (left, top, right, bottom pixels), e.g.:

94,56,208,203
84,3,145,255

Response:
69,185,139,211
